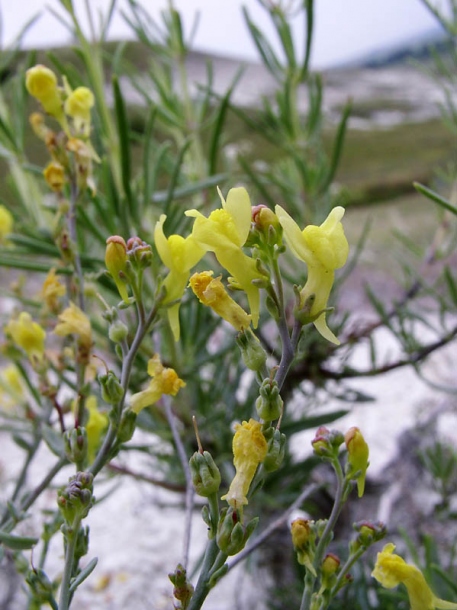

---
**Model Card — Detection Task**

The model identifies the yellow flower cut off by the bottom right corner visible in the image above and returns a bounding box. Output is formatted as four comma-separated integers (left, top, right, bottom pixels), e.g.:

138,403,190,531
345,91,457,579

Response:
371,542,457,610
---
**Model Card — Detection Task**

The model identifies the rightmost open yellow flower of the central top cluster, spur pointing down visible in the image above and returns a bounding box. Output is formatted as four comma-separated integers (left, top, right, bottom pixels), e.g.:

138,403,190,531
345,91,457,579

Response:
276,205,349,345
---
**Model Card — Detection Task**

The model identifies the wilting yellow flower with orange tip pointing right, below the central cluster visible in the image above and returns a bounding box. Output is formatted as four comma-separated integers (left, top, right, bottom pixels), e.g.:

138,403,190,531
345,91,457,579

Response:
130,354,186,413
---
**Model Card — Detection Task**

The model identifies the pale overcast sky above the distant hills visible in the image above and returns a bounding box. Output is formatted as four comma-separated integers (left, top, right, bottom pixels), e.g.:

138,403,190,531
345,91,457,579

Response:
0,0,443,68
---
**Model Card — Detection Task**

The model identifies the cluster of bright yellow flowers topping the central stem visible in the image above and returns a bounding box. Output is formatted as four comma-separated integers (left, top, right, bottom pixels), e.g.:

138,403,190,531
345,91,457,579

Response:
154,187,349,344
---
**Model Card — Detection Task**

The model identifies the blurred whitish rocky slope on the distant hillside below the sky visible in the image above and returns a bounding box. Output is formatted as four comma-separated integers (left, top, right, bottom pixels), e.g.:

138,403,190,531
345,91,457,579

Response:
123,53,445,129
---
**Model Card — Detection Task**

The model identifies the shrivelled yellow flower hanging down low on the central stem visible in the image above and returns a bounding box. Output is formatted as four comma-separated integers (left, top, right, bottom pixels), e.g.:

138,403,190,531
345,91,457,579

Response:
221,419,267,510
